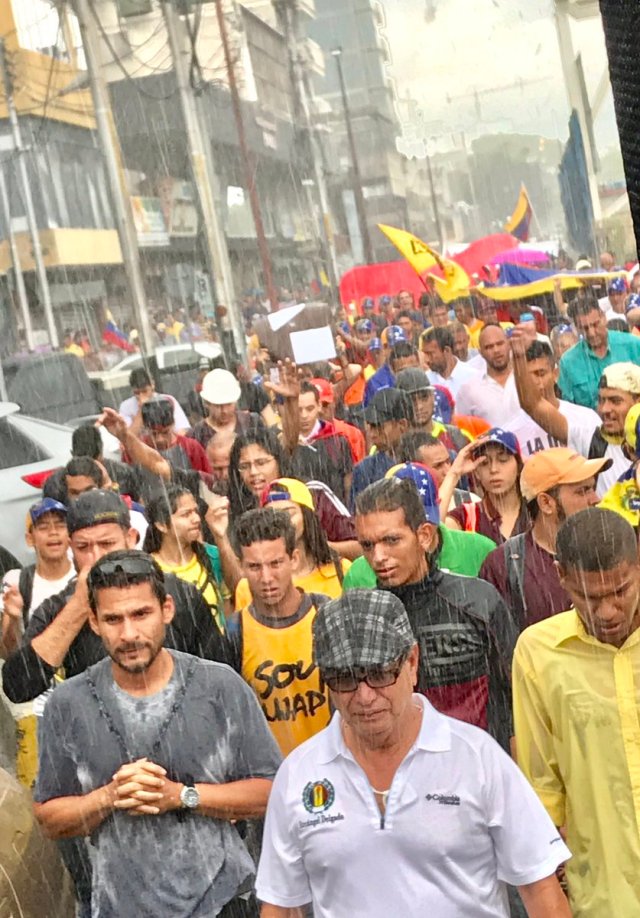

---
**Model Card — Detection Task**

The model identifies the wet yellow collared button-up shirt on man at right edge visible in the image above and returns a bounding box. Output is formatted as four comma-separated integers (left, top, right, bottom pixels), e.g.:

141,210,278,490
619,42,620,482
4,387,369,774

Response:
513,610,640,918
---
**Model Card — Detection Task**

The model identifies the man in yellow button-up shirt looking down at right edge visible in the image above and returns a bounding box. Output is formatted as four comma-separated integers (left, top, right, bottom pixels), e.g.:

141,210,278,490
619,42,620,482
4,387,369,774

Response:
513,508,640,918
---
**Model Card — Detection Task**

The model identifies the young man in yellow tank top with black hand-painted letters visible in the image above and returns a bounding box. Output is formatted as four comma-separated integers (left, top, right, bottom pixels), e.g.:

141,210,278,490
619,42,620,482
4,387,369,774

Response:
227,507,331,755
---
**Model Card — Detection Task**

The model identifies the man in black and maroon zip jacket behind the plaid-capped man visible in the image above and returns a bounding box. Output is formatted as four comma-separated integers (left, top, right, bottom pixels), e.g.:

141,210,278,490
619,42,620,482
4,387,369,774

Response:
356,478,518,750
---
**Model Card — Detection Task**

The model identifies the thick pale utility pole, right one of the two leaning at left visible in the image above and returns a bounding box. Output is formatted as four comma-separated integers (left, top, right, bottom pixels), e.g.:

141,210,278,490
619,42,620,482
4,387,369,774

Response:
161,0,247,359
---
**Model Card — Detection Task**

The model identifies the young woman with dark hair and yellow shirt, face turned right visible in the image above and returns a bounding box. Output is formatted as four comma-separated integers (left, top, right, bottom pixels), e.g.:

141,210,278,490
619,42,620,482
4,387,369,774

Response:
144,484,225,631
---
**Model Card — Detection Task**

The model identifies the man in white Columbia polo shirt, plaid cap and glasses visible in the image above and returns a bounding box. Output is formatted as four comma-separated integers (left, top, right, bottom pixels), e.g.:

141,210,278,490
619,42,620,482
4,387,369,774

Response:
256,590,571,918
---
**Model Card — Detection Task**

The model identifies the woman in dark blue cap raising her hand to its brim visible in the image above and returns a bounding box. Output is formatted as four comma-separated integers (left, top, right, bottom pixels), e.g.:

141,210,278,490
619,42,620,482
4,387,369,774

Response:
440,427,530,545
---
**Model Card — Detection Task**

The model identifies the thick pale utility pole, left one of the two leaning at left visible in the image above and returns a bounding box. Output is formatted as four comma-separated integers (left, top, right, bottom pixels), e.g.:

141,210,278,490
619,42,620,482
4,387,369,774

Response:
74,0,155,355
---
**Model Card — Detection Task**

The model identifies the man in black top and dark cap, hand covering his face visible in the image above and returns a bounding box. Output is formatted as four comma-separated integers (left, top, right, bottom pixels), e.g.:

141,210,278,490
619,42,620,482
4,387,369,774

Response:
2,491,227,703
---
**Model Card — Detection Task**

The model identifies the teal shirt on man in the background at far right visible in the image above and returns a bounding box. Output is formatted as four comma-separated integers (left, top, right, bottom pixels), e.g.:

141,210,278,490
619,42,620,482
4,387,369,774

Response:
558,331,640,408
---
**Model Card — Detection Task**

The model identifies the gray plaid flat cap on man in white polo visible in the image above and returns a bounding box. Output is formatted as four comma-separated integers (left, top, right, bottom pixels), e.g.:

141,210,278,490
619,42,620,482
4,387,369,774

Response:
313,590,416,671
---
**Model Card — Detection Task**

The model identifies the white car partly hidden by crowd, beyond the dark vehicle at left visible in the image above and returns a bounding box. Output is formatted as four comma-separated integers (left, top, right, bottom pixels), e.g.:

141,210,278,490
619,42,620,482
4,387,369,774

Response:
88,341,224,408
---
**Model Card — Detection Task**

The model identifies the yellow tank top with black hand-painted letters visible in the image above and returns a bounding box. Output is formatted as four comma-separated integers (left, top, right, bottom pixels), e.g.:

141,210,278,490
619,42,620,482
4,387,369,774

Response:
240,606,331,755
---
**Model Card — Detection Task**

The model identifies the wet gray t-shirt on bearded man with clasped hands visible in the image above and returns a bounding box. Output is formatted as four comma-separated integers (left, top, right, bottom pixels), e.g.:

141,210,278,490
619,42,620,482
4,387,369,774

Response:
35,651,280,918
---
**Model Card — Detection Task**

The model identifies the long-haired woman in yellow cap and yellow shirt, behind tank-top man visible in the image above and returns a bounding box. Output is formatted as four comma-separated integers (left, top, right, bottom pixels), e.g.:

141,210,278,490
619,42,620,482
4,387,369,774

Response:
236,478,351,609
